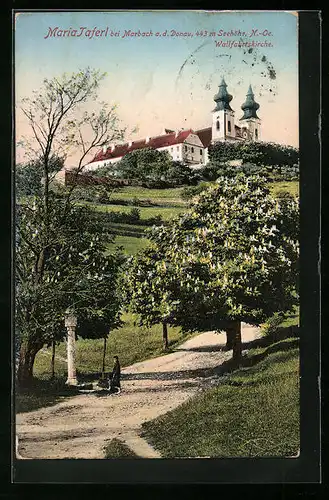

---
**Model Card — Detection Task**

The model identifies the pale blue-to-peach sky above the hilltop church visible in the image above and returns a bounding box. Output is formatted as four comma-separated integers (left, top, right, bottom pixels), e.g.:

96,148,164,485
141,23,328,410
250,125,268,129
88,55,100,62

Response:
15,11,298,164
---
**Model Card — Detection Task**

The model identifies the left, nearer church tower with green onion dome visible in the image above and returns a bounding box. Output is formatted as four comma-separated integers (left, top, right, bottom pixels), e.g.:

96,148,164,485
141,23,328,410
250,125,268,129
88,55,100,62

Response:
212,78,235,142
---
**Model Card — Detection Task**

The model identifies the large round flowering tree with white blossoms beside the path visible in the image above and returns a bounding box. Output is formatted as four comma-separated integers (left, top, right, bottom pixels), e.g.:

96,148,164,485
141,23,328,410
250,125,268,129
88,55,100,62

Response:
138,175,298,362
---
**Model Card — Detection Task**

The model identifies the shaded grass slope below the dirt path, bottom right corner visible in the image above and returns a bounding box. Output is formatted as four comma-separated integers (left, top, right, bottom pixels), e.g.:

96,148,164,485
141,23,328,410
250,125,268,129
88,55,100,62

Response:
142,339,299,458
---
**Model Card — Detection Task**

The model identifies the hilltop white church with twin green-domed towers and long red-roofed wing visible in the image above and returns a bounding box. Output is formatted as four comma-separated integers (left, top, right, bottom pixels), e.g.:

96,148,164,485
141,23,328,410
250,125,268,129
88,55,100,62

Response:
86,78,261,170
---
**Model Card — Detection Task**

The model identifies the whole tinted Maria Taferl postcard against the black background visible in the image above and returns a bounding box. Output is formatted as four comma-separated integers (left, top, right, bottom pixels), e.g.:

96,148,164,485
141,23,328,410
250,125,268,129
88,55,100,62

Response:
14,10,320,482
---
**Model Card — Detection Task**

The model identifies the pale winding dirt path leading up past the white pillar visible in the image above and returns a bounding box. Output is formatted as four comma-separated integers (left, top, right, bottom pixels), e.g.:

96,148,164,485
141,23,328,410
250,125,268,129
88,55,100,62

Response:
16,324,260,459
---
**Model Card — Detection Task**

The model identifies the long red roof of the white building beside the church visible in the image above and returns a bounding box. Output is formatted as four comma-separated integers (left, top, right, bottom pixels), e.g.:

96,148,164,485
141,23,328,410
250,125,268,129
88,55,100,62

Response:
91,129,194,163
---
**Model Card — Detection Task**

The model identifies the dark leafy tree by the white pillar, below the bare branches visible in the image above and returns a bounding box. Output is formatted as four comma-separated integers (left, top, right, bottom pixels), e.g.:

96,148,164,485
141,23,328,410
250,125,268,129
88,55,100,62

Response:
16,196,122,383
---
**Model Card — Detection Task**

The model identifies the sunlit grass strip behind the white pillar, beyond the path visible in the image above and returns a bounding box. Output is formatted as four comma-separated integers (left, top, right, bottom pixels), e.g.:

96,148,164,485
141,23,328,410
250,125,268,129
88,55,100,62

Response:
34,314,195,378
